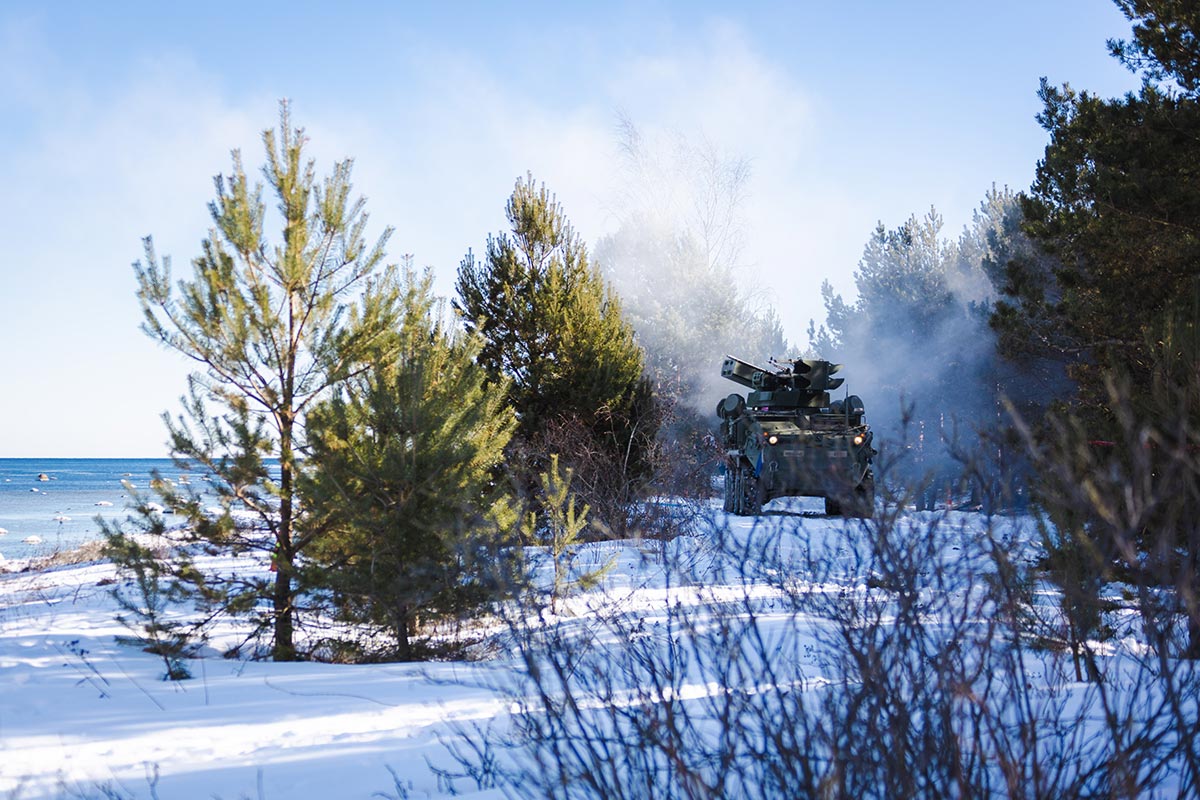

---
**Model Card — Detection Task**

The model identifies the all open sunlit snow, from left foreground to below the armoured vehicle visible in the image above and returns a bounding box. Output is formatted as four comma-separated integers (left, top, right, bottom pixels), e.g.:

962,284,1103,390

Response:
0,500,1185,800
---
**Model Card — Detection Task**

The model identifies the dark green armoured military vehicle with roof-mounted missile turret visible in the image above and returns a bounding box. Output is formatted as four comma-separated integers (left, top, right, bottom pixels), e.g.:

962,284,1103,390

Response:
716,356,875,517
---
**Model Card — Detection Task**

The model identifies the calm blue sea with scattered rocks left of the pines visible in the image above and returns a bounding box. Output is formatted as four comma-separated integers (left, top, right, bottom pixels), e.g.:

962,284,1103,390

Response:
0,458,182,559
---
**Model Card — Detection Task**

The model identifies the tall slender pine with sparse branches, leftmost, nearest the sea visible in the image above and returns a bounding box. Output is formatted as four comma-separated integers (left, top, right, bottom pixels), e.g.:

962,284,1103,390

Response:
134,102,396,660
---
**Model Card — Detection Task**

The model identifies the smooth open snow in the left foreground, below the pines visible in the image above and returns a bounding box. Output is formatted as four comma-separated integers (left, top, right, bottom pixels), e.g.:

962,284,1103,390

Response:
0,554,511,799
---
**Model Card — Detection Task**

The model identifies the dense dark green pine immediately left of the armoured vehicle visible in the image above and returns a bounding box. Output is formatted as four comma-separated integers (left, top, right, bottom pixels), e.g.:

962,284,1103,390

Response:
455,176,658,525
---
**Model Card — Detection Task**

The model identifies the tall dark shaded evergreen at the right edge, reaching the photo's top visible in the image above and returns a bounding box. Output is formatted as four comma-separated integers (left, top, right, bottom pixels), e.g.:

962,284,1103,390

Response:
994,0,1200,657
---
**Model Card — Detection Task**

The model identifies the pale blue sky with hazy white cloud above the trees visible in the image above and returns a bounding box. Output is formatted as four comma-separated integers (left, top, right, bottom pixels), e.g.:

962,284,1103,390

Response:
0,0,1136,457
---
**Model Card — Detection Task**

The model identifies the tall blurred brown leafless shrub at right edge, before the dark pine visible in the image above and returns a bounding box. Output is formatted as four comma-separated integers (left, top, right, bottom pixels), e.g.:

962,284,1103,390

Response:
1021,375,1200,796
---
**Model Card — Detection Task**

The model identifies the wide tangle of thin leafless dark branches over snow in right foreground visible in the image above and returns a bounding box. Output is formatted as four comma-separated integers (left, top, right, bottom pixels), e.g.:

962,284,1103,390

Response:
441,434,1200,799
